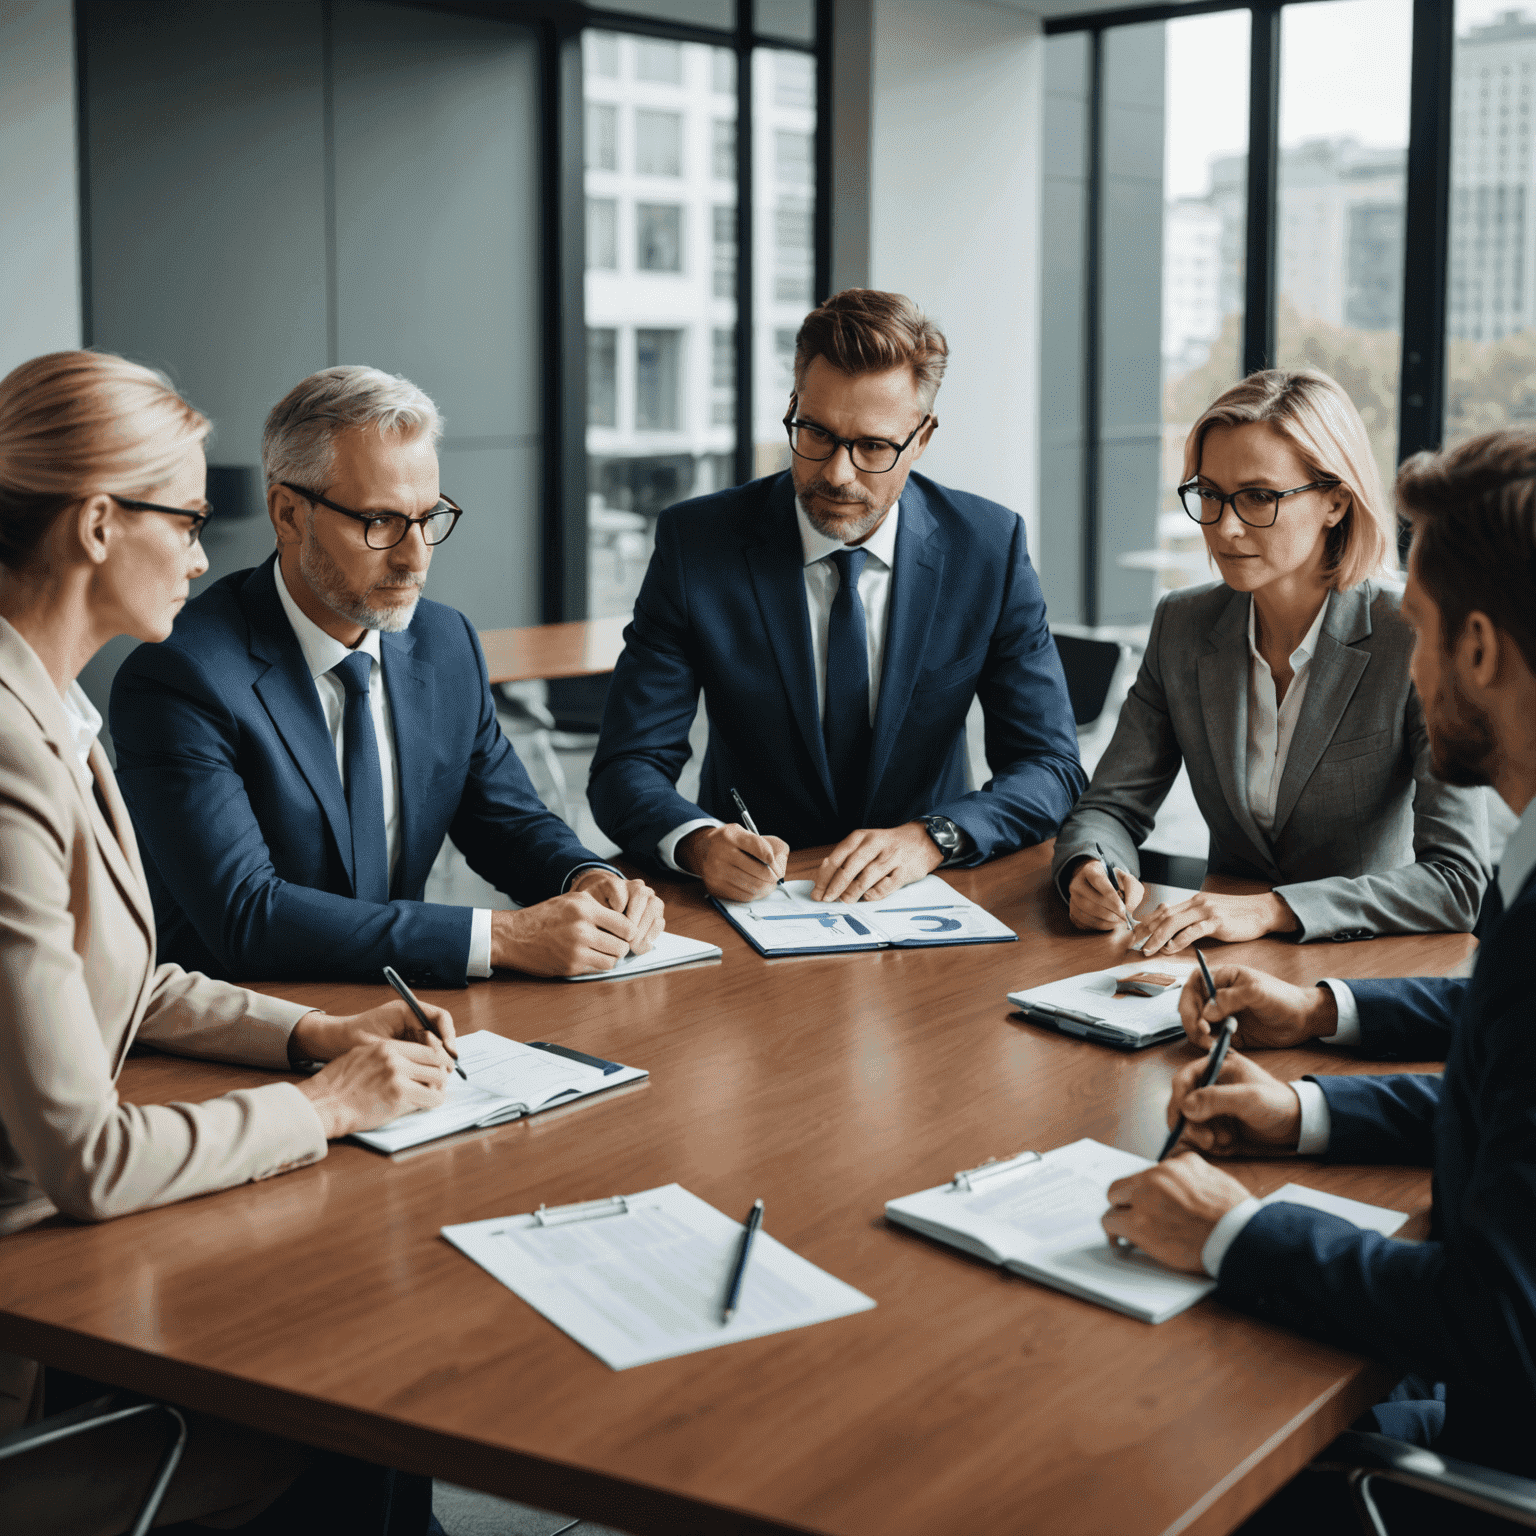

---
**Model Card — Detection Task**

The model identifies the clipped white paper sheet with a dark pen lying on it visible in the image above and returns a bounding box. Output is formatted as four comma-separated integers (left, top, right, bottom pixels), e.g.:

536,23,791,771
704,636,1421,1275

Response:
442,1184,874,1370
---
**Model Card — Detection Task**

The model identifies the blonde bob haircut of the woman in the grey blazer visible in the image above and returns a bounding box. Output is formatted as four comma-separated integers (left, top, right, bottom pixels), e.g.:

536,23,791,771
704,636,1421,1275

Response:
1183,369,1398,591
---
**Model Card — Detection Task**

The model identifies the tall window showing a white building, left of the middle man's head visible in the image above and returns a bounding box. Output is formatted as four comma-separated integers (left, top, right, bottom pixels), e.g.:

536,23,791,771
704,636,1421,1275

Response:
582,0,826,617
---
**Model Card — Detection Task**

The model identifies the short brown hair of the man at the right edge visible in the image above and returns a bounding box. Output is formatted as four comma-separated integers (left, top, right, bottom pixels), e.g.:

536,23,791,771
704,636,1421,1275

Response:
1398,427,1536,671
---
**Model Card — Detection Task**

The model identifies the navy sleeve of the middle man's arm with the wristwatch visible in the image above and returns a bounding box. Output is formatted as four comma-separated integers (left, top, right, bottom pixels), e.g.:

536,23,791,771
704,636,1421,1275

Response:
929,518,1087,863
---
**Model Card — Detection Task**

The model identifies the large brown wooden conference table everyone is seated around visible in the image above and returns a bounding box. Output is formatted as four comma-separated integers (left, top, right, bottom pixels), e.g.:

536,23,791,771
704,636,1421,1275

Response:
0,848,1471,1536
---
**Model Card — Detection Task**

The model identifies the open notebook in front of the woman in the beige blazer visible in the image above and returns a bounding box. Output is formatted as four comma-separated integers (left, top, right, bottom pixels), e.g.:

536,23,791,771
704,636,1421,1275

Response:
353,1029,648,1152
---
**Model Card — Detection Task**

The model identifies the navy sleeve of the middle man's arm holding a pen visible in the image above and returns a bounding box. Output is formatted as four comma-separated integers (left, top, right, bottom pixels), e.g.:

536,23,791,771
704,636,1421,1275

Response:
587,513,708,859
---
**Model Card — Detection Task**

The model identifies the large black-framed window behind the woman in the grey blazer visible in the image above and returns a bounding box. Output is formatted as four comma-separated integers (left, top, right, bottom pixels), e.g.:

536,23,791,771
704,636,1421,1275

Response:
1041,0,1462,625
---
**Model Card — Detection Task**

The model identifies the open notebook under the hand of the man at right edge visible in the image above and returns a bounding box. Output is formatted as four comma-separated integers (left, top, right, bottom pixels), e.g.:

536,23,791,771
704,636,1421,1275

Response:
885,1137,1409,1322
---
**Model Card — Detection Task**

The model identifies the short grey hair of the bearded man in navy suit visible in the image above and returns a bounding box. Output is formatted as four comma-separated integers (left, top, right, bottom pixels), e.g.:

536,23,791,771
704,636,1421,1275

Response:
261,367,442,490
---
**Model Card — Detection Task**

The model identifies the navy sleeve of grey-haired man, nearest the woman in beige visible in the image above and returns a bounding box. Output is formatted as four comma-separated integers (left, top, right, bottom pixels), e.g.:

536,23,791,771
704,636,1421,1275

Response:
112,645,472,986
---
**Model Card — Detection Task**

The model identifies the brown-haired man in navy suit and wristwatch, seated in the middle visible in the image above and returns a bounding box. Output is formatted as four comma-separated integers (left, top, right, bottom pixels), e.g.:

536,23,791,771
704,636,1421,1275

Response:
588,289,1084,902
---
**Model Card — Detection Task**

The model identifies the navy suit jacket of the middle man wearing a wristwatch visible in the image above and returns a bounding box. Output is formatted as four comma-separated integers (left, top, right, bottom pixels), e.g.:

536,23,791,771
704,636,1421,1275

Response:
588,473,1086,866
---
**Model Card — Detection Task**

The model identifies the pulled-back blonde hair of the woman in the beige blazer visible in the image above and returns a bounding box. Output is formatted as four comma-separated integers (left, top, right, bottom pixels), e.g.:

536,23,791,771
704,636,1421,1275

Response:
0,352,210,570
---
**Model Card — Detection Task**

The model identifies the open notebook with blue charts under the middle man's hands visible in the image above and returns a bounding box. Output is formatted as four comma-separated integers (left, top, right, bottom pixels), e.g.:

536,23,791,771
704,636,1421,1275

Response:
711,874,1018,955
